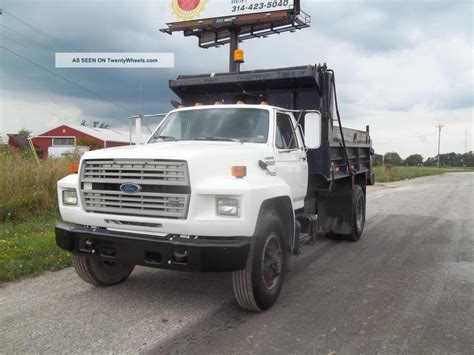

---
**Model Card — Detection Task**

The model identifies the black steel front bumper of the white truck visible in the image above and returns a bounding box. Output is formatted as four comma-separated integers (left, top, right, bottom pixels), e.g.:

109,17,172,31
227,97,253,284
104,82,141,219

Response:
56,224,250,272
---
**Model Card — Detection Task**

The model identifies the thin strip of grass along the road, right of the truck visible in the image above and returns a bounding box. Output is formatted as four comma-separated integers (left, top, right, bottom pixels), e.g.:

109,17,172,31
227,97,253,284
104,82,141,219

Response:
374,166,474,182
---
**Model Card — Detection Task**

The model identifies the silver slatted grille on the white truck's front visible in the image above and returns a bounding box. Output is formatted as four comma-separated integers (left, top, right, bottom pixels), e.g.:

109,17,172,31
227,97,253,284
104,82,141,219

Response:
81,159,190,219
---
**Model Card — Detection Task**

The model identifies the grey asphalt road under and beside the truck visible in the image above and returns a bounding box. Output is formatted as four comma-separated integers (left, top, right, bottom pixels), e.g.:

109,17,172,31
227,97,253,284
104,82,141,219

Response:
0,173,474,354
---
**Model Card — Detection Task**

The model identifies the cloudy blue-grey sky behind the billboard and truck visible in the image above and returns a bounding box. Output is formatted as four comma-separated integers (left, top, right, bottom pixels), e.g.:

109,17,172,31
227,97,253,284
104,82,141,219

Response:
0,0,474,157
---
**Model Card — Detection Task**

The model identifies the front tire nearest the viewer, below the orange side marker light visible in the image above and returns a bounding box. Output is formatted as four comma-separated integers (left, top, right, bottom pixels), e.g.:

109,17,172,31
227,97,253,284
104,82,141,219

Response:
232,211,287,312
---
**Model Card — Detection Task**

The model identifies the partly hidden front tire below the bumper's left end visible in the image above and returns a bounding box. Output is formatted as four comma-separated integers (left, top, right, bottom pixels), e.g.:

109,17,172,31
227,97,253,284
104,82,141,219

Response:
72,255,135,287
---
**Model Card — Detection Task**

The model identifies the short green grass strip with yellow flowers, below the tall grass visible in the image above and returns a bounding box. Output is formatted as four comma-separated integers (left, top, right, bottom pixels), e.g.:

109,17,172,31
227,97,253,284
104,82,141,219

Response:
0,217,71,286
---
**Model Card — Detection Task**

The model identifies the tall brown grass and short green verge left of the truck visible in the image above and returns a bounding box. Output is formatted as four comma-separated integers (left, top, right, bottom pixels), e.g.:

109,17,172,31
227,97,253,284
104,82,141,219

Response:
0,150,70,285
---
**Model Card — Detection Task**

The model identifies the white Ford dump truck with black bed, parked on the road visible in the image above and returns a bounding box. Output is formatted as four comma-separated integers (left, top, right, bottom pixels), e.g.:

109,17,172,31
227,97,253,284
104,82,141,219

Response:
56,65,374,311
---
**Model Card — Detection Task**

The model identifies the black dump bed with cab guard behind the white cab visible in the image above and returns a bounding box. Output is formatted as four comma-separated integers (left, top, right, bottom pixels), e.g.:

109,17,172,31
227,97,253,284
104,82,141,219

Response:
169,65,373,185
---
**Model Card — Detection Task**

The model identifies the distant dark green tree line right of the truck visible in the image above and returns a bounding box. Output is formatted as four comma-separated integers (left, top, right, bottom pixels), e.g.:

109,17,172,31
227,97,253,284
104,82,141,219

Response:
375,151,474,167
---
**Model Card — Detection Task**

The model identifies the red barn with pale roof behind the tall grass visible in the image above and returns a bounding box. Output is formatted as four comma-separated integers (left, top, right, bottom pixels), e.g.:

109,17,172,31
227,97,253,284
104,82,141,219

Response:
32,124,130,158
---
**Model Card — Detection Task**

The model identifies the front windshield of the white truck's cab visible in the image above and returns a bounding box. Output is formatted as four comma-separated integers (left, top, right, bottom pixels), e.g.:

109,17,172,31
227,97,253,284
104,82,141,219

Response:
148,108,269,143
